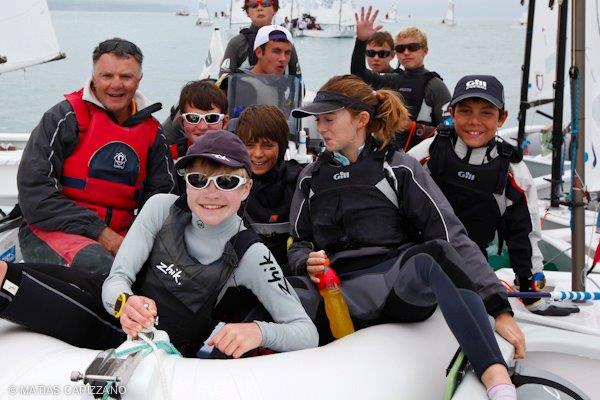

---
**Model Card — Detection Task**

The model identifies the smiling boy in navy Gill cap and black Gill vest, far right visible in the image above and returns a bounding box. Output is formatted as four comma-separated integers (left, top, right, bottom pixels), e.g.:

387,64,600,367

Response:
409,75,578,315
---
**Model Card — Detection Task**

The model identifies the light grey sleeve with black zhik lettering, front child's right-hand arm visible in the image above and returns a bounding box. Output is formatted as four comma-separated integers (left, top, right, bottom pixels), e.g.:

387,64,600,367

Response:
222,243,319,351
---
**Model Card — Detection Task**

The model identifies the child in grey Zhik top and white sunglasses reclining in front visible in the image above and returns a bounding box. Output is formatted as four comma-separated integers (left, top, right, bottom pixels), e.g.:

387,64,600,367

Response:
0,131,318,357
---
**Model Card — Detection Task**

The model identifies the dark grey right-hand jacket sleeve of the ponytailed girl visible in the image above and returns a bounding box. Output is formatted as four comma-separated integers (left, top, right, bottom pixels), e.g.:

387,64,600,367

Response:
390,152,511,317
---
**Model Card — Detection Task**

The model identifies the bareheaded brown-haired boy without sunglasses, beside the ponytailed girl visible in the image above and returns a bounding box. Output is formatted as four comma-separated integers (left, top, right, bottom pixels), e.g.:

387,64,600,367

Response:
235,105,302,273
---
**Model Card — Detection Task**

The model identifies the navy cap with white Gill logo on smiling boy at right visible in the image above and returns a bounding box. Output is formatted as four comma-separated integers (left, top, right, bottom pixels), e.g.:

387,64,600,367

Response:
450,75,504,109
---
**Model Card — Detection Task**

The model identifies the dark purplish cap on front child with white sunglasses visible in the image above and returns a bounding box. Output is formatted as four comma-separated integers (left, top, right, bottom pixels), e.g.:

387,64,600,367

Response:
175,130,252,176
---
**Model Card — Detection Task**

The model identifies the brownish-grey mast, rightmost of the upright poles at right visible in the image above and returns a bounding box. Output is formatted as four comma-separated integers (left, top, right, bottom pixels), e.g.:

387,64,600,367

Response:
569,0,586,291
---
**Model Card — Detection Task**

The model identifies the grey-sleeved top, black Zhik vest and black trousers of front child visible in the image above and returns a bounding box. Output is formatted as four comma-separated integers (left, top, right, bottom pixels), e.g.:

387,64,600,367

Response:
0,194,317,355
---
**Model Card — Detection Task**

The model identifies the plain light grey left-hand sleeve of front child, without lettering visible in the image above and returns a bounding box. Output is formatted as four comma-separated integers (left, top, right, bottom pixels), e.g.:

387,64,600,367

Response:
102,194,177,314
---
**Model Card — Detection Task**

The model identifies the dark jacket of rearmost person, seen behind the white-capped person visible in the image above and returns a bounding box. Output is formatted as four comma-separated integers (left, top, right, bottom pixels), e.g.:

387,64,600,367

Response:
219,25,302,75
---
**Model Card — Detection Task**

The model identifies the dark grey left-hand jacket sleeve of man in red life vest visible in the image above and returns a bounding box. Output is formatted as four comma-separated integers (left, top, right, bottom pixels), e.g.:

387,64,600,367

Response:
17,101,106,239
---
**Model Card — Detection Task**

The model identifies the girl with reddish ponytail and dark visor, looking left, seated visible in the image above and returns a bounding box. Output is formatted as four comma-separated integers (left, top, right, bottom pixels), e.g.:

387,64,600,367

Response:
288,75,525,399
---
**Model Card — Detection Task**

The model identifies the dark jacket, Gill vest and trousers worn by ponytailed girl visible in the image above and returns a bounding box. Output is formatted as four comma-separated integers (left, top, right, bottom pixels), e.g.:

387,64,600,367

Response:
288,139,511,376
